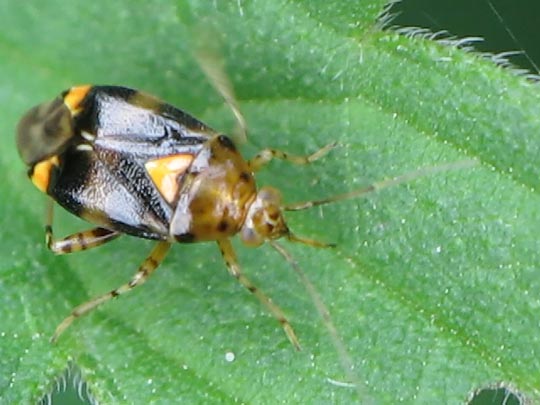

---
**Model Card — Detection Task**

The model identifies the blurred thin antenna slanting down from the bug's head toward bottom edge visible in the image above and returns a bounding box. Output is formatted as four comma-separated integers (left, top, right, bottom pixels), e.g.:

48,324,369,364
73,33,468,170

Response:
268,241,371,403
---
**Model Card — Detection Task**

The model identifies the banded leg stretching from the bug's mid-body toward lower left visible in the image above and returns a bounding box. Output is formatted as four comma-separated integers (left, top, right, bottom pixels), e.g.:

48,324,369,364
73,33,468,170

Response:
51,242,171,343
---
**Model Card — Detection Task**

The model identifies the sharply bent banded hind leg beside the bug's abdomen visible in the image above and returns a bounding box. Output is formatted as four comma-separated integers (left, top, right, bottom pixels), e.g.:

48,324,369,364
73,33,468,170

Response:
45,200,121,255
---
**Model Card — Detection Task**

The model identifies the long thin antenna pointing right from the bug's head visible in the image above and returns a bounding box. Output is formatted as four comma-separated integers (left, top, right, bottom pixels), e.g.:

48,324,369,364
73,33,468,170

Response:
283,159,478,211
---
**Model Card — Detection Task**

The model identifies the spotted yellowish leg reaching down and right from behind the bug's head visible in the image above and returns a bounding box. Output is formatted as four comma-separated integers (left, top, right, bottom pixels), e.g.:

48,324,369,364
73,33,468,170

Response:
217,239,300,350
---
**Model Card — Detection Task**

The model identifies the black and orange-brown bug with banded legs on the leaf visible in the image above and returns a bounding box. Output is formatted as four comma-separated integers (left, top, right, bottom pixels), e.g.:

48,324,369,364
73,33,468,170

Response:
17,79,472,349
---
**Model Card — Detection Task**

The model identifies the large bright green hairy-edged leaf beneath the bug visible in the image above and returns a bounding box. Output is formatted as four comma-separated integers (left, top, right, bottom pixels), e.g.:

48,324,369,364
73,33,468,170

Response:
0,0,540,403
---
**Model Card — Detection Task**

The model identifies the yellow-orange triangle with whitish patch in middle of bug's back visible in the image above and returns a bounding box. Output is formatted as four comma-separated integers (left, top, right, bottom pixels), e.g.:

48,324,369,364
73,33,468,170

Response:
144,153,193,203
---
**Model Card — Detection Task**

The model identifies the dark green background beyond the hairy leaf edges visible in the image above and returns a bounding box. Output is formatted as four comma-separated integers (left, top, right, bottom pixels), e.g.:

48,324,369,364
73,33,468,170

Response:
42,0,540,405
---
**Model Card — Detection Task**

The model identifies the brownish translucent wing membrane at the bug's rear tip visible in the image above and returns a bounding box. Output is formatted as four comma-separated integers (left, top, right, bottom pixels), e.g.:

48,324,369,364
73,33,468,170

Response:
17,97,73,166
